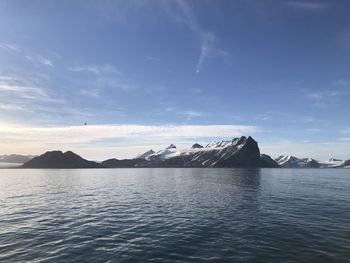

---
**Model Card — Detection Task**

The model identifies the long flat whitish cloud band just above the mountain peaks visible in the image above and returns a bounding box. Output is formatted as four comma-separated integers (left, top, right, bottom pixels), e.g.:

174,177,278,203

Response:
0,124,260,143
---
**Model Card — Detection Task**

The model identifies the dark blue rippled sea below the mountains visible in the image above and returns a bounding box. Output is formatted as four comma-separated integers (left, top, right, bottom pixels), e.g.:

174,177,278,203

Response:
0,168,350,263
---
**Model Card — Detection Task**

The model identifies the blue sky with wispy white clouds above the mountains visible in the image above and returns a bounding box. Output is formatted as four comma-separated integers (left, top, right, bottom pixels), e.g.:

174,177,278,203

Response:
0,0,350,160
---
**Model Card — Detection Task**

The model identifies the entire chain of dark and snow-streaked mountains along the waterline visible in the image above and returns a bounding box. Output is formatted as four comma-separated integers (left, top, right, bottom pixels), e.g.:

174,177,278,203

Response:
17,136,350,168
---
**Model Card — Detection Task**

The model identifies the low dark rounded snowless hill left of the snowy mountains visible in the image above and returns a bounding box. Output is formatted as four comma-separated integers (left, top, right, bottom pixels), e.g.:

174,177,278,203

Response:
21,151,104,168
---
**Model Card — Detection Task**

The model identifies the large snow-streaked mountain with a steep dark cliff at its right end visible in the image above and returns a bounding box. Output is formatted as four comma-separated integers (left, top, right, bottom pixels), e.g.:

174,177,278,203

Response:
102,136,270,167
